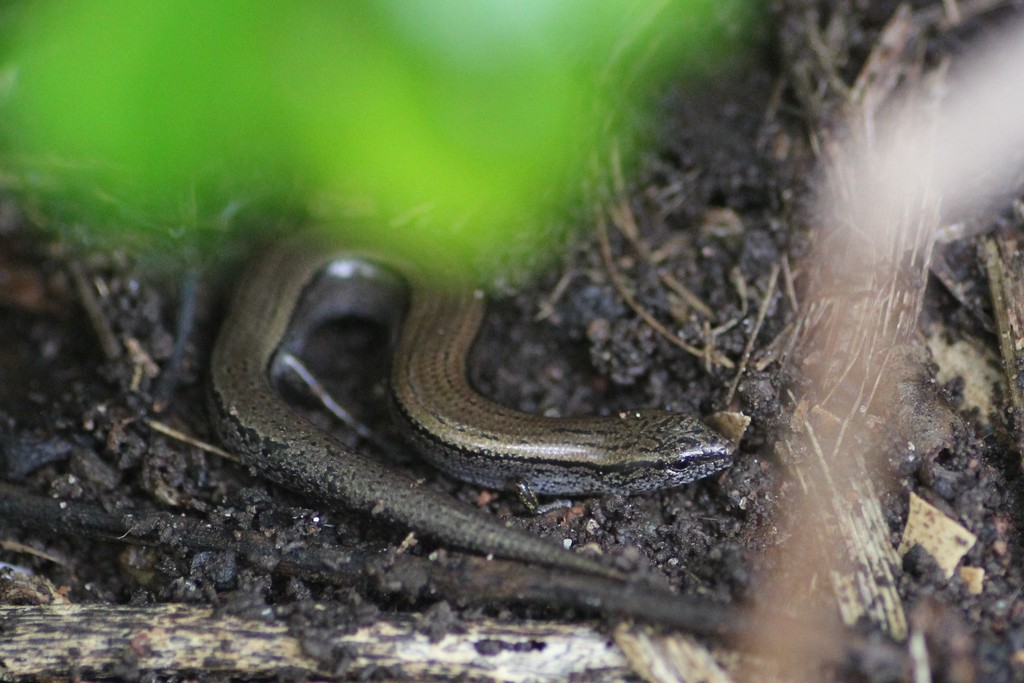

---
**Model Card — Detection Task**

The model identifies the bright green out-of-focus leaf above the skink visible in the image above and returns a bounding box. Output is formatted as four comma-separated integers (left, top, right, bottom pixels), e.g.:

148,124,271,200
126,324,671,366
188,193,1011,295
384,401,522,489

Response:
3,0,757,272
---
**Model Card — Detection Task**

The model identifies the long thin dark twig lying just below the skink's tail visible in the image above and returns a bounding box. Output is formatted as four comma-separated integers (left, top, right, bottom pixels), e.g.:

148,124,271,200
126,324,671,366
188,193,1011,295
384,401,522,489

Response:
0,482,901,675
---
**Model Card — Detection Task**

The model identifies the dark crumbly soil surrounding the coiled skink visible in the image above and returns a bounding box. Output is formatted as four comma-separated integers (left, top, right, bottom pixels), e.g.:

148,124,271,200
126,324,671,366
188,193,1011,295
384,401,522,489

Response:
0,2,1024,681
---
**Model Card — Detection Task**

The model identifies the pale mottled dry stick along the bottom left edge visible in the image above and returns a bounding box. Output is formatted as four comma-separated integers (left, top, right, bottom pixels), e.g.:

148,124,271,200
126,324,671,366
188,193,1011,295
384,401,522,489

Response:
0,604,631,681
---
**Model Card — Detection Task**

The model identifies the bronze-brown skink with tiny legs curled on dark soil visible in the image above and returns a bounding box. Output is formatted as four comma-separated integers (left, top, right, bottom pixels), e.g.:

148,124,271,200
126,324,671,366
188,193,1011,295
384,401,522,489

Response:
209,233,732,575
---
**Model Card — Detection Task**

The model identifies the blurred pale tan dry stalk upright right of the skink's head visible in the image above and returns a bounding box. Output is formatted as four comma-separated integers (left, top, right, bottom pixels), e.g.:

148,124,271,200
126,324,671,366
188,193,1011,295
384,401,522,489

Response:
763,3,1024,674
